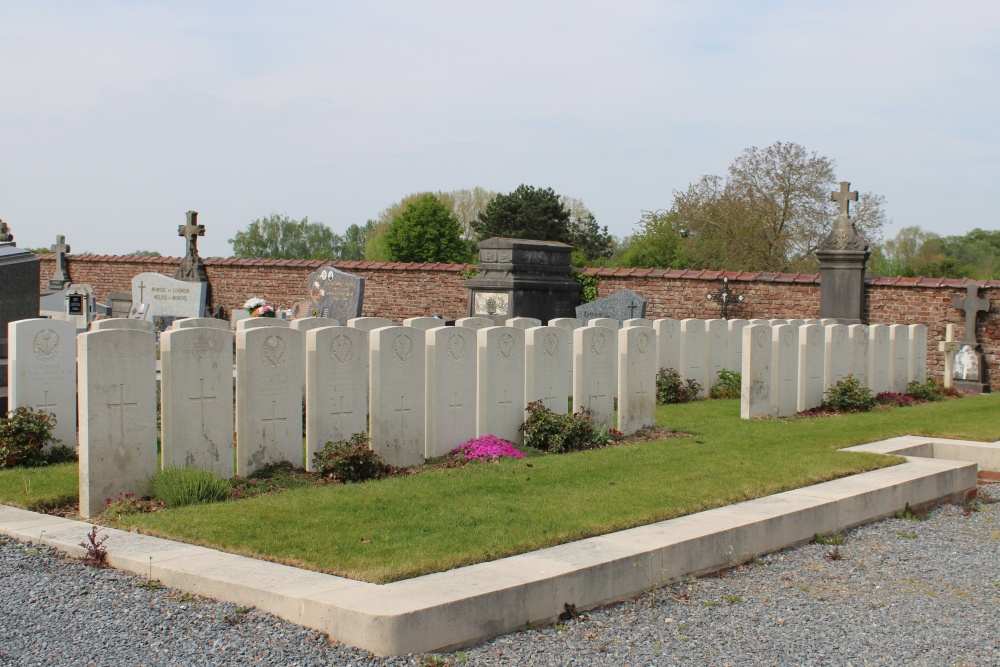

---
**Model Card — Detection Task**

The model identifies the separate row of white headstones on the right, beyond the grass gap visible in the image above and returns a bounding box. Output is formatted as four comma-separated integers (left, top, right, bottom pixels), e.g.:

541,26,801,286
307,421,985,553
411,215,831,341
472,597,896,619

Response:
740,324,927,419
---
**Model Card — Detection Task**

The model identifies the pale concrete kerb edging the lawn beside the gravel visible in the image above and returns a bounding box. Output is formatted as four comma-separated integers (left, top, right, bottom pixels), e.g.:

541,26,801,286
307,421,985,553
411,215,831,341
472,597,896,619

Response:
0,436,984,655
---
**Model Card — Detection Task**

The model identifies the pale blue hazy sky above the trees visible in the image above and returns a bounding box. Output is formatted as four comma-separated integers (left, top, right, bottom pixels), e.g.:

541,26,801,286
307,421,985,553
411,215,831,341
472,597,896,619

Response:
0,0,1000,256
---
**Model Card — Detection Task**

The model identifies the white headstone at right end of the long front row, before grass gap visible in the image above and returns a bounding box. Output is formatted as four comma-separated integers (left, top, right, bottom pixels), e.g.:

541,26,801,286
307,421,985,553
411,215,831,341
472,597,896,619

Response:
618,326,656,435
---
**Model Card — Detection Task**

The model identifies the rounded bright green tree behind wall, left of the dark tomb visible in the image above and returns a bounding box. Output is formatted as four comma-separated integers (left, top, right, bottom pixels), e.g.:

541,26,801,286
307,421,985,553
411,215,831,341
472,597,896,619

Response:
385,193,469,263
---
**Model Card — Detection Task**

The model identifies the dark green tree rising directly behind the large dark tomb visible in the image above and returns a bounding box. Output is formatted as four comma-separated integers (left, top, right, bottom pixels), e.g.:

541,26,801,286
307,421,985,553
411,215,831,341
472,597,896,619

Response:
471,184,573,243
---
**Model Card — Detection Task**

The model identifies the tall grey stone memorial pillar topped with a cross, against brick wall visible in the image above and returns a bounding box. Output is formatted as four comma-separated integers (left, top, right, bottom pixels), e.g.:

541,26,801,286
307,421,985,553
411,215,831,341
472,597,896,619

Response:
816,181,871,324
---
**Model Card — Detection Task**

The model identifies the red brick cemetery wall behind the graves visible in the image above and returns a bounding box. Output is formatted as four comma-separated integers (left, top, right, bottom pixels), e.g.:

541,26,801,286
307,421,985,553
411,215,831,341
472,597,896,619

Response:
40,255,1000,390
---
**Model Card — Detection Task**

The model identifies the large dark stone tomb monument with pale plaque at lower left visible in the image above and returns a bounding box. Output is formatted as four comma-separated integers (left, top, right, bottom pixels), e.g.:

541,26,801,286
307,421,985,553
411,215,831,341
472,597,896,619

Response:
465,237,580,326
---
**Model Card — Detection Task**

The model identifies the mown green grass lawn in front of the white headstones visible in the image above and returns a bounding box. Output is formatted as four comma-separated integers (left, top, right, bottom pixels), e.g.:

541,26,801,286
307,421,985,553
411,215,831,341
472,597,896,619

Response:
0,396,1000,582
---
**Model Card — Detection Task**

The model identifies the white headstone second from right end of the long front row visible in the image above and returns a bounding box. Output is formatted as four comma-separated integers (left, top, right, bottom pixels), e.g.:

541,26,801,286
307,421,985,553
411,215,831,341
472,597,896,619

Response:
573,326,618,428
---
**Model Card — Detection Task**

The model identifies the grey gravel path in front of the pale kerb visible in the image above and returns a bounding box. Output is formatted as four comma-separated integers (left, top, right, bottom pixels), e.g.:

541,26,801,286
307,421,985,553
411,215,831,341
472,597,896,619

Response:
0,485,1000,667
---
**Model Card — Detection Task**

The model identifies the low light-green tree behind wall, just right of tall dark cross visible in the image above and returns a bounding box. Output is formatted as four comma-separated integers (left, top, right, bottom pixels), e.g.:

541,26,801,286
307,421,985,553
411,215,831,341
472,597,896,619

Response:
229,213,343,259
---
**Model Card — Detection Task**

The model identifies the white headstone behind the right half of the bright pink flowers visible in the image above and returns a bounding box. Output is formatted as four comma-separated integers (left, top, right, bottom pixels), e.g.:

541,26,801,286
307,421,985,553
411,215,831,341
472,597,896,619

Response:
476,327,525,444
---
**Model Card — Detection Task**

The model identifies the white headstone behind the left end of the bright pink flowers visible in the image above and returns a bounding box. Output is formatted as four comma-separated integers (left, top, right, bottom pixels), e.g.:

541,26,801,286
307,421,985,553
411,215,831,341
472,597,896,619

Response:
424,327,478,458
